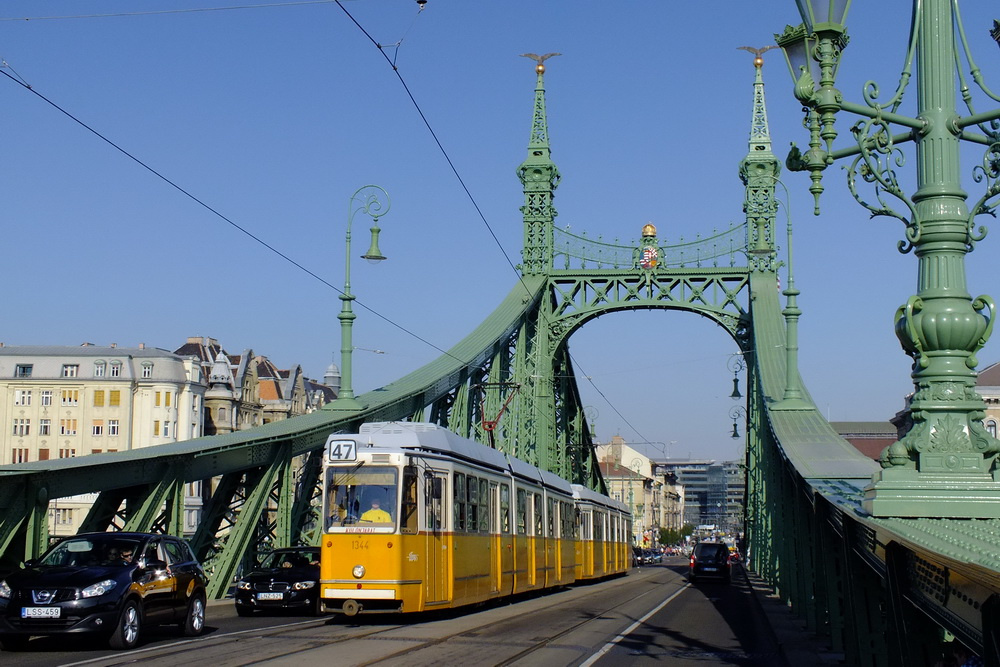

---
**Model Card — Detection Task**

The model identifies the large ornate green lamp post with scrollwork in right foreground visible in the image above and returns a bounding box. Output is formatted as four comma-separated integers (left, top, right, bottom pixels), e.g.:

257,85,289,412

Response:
775,0,1000,518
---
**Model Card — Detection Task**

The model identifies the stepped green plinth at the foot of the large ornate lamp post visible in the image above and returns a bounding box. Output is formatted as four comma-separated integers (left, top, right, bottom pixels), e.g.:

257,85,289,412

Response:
861,468,1000,519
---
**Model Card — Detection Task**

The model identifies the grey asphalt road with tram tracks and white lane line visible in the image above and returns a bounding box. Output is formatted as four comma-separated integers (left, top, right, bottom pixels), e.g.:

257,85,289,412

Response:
0,558,783,667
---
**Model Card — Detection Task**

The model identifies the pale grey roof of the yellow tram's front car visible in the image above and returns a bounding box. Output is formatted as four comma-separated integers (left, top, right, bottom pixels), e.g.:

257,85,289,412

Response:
358,422,573,496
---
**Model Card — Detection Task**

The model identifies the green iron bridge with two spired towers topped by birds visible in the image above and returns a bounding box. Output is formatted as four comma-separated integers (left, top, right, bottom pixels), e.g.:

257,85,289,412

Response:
0,2,1000,666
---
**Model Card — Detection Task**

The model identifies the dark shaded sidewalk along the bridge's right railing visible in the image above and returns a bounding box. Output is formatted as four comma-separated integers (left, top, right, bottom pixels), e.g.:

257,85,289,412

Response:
740,567,844,667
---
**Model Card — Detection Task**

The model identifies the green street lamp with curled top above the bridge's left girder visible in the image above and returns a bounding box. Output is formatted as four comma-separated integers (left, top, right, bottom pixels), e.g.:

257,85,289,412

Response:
330,185,390,410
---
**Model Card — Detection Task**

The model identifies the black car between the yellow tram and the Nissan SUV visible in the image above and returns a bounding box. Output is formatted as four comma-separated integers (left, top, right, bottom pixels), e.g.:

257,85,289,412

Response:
235,547,320,616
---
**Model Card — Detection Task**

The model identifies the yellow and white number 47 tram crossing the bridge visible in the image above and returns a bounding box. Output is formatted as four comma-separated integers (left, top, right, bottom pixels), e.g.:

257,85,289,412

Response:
320,422,632,616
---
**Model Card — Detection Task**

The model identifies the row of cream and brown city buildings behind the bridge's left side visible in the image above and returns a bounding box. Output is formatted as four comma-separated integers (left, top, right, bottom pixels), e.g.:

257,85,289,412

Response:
0,337,338,536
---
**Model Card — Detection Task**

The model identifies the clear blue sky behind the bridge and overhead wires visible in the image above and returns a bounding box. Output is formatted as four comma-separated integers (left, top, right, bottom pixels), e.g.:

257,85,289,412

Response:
0,0,1000,458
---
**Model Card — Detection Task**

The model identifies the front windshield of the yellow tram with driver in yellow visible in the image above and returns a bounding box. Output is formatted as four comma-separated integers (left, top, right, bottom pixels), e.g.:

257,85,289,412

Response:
324,466,399,530
